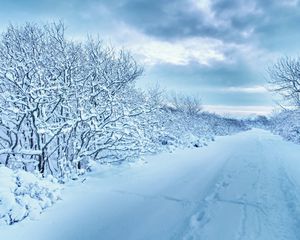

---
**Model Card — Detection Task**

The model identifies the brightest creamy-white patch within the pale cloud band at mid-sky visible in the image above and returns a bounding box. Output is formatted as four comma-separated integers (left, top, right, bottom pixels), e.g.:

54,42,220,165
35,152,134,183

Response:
122,31,226,66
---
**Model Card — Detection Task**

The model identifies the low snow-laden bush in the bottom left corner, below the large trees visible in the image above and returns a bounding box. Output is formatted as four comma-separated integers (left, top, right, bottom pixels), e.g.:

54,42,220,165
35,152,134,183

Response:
0,165,61,225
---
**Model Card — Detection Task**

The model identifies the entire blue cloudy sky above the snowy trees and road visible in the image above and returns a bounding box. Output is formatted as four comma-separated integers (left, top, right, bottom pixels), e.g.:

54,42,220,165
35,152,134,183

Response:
0,0,300,114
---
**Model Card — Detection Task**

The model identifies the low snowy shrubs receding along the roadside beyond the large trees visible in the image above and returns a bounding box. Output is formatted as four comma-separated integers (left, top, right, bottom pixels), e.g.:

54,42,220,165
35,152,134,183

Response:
143,106,249,150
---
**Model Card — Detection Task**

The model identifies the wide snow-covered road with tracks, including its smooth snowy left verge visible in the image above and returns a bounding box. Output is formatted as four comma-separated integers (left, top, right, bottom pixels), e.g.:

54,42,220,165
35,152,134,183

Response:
0,129,300,240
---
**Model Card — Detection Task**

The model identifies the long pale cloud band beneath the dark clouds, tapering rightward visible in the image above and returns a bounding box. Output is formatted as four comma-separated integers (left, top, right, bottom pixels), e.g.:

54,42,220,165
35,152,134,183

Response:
91,23,274,69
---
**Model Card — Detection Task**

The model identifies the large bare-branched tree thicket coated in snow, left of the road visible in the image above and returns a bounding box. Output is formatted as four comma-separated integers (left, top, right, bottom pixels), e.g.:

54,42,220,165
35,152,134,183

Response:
0,23,144,178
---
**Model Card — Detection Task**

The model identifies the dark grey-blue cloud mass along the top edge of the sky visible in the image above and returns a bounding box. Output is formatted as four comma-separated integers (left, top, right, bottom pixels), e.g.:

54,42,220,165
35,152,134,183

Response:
98,0,264,42
